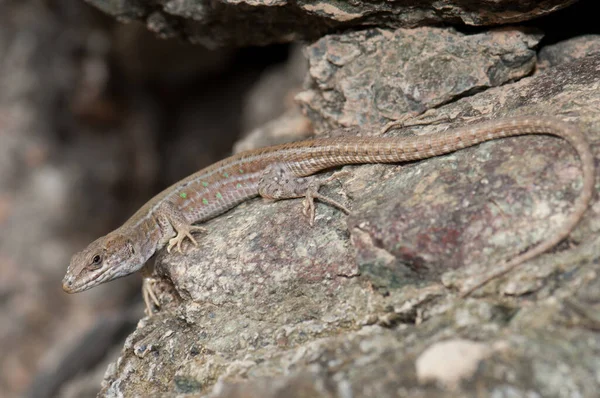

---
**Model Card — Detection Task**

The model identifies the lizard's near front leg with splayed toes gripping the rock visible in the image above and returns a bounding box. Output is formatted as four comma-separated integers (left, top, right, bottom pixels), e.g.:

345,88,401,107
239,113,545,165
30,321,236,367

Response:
154,201,206,253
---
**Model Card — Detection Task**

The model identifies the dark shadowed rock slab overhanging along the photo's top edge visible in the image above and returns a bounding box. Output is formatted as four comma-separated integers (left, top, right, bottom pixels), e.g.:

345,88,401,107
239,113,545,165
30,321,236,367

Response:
86,0,575,47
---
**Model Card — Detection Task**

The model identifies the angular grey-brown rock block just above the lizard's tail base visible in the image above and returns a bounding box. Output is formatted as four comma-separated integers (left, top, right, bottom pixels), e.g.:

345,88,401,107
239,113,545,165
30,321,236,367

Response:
297,28,541,130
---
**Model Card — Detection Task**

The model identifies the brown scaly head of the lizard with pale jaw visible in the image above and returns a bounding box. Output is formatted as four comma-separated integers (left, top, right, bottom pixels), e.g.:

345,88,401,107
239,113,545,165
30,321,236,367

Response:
63,231,145,293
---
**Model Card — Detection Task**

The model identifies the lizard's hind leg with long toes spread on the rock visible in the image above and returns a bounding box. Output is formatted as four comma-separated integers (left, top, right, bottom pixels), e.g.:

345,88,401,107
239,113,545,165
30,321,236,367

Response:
258,164,350,225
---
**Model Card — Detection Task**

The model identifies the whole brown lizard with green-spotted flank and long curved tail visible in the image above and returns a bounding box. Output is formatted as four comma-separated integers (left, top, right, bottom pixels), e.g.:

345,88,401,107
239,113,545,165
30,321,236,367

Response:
63,116,594,305
